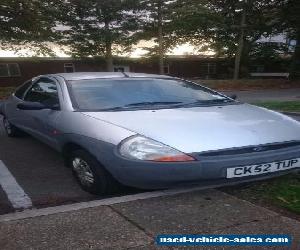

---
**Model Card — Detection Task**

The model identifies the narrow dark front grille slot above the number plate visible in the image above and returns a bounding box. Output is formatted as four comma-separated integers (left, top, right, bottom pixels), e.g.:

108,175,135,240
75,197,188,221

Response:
199,141,300,156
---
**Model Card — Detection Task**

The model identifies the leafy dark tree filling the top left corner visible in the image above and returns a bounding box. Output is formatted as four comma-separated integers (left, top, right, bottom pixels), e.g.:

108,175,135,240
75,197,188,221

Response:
0,0,59,55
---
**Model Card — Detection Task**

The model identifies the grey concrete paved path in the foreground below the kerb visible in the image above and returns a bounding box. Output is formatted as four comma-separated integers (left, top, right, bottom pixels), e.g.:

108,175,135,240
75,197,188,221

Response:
0,190,300,250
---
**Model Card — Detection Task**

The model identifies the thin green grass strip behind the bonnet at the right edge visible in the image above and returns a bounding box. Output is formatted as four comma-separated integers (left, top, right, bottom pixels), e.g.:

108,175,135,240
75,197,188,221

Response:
252,101,300,112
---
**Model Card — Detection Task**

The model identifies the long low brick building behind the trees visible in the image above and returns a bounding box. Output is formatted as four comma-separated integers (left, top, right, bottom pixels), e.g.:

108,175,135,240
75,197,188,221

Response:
0,57,232,87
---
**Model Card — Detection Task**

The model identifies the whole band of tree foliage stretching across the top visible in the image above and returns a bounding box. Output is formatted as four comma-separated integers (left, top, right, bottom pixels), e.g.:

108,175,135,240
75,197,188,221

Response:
0,0,300,78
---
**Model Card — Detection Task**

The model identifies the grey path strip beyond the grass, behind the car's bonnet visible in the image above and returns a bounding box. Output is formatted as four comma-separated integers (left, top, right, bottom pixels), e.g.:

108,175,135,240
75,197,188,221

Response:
223,88,300,102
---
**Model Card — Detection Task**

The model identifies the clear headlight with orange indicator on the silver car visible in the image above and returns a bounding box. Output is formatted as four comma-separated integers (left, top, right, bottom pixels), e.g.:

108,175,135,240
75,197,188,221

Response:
119,135,195,162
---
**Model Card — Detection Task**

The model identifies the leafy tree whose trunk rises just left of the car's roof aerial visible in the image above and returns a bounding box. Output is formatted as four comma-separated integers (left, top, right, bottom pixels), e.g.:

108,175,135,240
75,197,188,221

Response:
61,0,138,71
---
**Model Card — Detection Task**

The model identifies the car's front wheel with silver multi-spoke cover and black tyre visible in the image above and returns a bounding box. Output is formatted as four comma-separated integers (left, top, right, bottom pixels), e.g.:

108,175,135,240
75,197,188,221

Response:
68,150,119,195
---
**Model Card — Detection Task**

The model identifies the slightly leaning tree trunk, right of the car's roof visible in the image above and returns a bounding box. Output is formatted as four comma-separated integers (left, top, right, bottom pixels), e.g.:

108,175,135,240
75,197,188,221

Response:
233,5,246,80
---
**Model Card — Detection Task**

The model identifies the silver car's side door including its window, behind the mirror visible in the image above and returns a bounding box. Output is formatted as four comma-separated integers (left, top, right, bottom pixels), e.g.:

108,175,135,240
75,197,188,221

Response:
24,77,61,147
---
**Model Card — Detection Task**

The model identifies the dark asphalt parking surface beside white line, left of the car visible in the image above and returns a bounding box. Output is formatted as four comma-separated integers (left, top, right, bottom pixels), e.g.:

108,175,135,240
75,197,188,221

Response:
0,113,300,214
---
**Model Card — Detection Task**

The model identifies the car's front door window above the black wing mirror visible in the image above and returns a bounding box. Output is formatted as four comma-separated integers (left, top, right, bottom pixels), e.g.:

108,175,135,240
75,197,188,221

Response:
24,78,59,106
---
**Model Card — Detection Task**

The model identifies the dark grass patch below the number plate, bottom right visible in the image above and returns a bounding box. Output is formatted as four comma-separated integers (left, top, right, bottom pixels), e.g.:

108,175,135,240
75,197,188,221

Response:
222,173,300,218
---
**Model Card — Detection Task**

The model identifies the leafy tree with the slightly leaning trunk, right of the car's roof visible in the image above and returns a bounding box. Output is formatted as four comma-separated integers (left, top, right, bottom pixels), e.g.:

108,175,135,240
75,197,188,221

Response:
173,0,281,78
